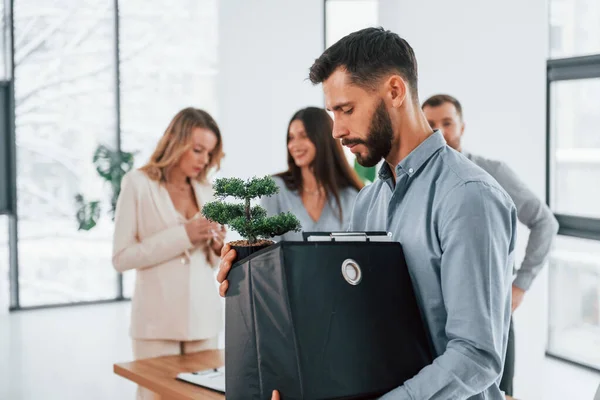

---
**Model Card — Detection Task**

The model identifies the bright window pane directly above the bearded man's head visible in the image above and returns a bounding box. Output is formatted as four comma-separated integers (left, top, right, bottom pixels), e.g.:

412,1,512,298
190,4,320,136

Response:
325,0,379,47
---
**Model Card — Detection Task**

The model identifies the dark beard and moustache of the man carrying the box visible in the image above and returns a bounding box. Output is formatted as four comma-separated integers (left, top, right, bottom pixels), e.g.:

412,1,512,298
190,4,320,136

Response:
342,100,394,167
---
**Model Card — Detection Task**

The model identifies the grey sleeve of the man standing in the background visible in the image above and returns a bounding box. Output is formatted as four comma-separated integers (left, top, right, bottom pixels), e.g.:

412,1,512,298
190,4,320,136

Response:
484,162,558,290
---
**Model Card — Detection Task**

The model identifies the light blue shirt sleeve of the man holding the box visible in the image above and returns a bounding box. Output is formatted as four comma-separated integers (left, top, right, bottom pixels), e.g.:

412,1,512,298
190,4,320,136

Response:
382,182,517,400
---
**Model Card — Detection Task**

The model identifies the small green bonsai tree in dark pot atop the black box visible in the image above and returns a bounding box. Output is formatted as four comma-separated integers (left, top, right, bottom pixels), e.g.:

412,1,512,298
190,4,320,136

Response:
202,176,301,260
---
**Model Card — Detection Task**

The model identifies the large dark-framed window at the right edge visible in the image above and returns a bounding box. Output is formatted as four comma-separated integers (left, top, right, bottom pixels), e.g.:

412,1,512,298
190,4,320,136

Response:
547,0,600,370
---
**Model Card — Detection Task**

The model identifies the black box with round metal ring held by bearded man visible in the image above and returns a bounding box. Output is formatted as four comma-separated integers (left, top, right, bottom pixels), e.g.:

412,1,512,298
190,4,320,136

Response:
225,242,432,400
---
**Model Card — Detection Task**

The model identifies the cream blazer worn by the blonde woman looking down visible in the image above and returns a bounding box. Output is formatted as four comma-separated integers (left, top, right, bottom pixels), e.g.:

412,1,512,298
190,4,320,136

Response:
112,170,223,341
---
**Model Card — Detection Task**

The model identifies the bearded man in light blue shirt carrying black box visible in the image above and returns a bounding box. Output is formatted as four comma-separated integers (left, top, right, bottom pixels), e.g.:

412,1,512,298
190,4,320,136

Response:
217,28,517,400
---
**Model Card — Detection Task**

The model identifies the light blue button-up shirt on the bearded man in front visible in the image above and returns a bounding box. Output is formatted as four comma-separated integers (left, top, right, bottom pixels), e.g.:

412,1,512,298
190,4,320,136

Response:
350,131,517,400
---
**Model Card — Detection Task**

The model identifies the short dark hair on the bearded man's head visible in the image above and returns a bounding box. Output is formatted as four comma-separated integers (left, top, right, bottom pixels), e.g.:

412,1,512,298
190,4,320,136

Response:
309,28,418,99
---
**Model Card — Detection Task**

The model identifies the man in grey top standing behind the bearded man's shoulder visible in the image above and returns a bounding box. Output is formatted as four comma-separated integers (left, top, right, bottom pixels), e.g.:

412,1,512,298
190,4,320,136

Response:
422,94,558,396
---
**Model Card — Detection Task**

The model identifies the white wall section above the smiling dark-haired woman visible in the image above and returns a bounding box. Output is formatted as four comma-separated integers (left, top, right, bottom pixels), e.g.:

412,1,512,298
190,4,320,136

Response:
218,0,323,177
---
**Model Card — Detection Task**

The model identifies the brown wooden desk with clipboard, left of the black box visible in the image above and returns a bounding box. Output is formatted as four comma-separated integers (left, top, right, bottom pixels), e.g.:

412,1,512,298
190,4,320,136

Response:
113,350,225,400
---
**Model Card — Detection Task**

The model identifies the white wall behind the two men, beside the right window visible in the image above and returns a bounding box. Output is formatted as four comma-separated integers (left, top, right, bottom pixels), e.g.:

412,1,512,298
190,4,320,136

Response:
379,0,598,400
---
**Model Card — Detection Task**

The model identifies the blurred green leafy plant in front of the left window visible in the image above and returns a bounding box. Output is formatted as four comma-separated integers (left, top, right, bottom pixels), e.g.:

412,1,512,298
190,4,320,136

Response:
75,145,134,231
